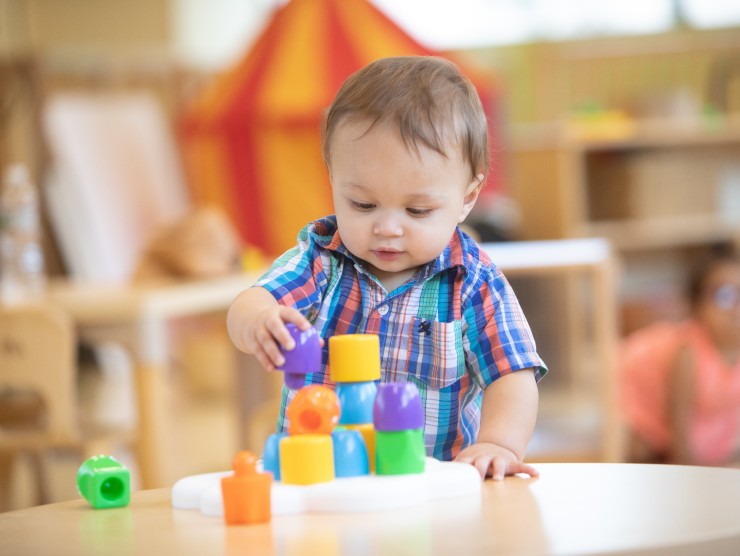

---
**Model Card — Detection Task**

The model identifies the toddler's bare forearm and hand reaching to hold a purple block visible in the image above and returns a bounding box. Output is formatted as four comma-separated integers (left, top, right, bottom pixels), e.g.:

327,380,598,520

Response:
226,287,311,371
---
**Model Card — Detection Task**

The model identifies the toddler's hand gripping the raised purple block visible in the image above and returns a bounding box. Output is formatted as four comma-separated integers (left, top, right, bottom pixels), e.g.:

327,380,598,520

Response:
245,305,323,371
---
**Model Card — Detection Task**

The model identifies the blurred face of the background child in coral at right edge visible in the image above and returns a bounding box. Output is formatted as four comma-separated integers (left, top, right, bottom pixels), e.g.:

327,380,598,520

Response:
697,263,740,347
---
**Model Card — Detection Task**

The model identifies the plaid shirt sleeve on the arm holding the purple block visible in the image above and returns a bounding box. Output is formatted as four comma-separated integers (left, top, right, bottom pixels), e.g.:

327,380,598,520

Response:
254,227,328,323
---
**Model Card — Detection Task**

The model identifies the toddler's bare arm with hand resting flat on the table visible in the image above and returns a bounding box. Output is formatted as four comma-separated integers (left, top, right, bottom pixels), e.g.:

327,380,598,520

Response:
455,369,539,480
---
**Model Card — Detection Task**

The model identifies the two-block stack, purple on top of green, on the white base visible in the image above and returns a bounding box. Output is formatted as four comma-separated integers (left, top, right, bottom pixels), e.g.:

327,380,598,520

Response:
373,382,426,475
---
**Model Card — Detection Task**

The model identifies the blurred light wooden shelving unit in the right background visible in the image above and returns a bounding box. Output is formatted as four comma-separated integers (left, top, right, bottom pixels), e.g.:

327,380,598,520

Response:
508,119,740,331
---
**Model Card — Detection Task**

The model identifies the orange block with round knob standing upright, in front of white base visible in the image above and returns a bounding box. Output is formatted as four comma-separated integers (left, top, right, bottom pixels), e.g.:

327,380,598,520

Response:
221,451,272,525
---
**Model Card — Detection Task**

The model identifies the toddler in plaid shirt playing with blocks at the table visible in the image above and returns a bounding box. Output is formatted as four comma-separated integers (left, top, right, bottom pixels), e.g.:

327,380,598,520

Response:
227,57,547,479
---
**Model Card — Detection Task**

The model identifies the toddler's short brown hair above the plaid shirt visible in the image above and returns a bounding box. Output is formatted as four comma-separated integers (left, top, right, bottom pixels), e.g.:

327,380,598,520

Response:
321,56,488,177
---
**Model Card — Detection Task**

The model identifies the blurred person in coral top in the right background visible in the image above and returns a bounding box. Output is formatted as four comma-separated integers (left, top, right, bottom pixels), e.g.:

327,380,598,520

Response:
620,248,740,465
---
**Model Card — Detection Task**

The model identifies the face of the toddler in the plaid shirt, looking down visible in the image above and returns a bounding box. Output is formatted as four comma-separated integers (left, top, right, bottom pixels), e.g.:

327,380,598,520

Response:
329,121,483,289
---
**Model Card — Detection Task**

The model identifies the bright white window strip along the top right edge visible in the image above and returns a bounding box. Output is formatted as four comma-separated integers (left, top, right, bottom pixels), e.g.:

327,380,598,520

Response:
371,0,740,50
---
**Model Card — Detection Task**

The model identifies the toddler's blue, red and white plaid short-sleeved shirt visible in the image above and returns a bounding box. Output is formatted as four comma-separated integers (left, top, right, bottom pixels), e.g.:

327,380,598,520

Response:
256,217,547,460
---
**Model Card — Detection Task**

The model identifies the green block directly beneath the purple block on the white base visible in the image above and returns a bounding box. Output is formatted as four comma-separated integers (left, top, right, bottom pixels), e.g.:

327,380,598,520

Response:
375,429,427,475
